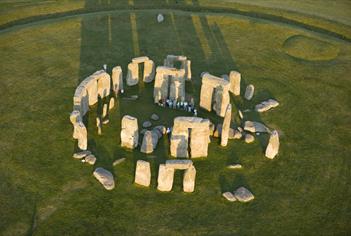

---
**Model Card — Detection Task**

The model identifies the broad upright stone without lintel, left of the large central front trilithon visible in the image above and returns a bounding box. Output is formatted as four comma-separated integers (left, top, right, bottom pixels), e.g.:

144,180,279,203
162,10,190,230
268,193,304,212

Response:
121,115,139,149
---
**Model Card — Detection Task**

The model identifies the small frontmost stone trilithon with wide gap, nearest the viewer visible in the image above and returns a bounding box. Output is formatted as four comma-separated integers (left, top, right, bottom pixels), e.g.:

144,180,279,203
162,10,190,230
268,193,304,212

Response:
157,160,196,193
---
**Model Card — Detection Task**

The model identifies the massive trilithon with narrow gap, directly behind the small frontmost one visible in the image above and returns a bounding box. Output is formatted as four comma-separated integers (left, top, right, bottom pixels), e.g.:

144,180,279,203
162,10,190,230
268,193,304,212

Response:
171,116,210,158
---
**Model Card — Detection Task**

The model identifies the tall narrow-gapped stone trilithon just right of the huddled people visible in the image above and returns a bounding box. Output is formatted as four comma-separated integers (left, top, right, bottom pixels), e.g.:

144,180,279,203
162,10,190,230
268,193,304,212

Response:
200,72,230,117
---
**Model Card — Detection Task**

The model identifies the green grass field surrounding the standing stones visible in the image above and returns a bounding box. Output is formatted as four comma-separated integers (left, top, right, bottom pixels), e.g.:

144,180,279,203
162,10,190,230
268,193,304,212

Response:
0,0,351,235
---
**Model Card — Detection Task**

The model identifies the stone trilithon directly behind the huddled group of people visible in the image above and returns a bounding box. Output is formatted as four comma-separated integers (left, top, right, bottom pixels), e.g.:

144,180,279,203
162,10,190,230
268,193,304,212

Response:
154,66,185,103
